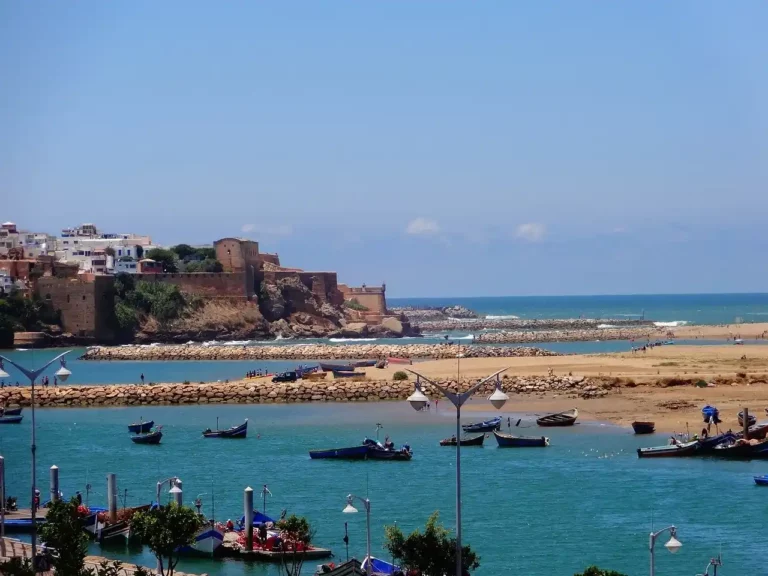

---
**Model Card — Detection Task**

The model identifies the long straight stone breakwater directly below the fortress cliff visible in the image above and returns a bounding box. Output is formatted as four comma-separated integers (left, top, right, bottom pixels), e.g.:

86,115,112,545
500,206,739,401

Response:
82,344,559,360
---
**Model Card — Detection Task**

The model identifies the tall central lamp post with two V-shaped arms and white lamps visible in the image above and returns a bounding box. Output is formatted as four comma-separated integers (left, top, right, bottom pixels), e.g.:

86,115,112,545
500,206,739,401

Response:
408,368,509,576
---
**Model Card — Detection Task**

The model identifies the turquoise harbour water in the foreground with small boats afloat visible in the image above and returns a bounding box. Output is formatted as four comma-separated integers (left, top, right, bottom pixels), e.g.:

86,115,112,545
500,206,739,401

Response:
0,402,768,576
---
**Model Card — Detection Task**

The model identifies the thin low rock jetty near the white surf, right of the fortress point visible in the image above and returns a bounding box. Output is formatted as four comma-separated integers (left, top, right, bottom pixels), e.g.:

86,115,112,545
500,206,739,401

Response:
414,318,658,332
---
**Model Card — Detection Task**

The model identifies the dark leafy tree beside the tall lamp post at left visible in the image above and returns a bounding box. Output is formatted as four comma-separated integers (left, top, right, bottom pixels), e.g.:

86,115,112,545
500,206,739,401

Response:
40,498,90,576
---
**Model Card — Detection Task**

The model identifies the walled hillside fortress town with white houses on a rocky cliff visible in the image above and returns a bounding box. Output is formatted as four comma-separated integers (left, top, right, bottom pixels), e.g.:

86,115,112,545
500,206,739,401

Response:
0,222,412,345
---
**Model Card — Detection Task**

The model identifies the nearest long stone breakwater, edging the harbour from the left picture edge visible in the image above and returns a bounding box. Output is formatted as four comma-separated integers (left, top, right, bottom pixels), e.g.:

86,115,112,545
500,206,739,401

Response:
0,376,612,408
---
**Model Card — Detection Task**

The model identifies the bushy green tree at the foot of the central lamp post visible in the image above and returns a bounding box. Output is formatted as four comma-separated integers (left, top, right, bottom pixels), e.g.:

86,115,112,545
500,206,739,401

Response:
384,512,480,576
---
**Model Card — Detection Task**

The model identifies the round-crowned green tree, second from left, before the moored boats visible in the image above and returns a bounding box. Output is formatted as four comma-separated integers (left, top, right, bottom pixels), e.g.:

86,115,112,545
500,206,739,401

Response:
131,503,202,576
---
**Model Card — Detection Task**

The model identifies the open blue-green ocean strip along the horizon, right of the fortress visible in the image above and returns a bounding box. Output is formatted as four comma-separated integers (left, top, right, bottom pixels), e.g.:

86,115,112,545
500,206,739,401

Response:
387,294,768,325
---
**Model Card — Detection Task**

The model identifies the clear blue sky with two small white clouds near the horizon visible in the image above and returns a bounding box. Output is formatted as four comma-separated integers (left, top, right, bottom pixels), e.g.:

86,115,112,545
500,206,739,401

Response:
0,0,768,296
